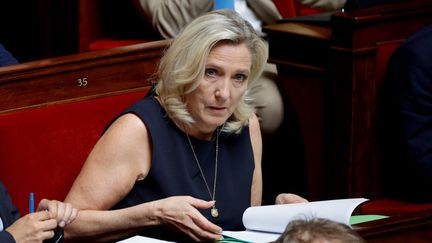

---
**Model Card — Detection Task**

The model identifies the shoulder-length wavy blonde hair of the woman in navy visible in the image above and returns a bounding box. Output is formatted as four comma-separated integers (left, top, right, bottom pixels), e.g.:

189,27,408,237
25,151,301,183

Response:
156,10,268,132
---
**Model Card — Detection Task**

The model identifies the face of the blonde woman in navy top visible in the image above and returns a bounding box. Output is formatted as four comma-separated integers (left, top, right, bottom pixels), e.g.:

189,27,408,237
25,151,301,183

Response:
186,43,252,136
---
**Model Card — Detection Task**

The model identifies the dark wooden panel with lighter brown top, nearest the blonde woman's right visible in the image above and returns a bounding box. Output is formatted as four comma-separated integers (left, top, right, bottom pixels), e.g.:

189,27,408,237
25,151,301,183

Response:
265,23,331,200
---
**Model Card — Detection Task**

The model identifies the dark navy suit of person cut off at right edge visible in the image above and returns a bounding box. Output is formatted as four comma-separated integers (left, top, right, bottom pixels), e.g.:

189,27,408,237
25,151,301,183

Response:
380,25,432,202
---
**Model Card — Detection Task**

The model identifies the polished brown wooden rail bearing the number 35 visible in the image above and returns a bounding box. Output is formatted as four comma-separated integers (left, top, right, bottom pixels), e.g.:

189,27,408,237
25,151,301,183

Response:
0,41,168,113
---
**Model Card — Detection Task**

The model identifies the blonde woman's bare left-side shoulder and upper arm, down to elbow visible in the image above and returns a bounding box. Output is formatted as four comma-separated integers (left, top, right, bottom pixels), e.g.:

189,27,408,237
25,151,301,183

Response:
66,114,151,209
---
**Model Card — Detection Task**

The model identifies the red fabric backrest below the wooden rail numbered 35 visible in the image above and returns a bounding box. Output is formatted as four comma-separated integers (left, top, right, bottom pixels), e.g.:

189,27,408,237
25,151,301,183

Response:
0,91,146,215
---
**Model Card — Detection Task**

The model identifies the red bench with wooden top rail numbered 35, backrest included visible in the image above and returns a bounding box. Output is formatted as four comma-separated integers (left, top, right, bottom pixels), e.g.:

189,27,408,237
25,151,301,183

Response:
0,41,167,214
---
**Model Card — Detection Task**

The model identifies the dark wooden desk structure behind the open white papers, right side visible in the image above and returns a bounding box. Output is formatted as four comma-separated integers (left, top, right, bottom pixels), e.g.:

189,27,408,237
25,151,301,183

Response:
264,1,432,200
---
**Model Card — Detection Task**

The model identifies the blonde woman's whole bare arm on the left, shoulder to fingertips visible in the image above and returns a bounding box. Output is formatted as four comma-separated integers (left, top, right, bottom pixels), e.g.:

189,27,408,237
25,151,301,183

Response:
65,114,221,241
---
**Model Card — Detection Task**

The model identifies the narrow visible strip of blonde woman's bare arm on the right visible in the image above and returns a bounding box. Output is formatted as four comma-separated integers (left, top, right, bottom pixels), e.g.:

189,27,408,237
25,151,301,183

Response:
249,115,262,206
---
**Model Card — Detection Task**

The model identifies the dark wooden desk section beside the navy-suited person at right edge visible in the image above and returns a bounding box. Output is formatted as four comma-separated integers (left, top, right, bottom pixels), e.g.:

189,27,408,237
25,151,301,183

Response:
326,1,432,198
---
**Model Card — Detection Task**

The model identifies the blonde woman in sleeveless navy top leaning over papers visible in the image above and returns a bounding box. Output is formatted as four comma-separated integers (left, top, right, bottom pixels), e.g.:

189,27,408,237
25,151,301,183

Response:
66,10,304,242
